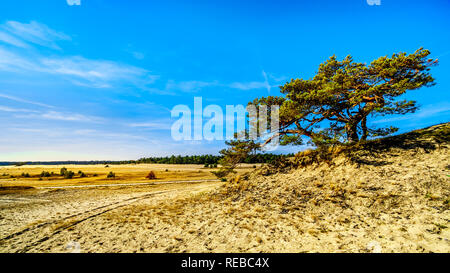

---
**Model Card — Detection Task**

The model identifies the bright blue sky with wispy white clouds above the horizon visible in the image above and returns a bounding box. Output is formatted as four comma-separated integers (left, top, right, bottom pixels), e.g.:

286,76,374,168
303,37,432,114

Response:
0,0,450,161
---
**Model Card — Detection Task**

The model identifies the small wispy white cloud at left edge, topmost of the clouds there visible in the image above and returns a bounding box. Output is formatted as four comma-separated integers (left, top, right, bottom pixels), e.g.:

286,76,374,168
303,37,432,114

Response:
0,21,71,49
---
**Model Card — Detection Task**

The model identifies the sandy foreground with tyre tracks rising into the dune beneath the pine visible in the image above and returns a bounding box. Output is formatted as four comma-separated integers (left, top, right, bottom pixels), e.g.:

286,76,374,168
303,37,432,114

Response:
0,124,450,253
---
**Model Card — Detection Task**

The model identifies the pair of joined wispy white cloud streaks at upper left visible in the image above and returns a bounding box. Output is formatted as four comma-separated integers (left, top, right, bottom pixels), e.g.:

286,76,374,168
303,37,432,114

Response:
0,21,159,91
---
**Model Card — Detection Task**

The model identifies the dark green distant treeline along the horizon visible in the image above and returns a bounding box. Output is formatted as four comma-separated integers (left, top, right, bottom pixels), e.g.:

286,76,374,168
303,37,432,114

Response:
0,154,294,166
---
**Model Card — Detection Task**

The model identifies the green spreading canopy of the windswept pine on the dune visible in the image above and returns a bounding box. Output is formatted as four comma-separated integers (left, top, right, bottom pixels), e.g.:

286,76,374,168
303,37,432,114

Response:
249,48,438,145
